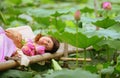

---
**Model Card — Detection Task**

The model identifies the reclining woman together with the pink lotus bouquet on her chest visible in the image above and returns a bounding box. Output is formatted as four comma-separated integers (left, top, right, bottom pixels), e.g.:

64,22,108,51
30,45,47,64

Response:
0,27,60,65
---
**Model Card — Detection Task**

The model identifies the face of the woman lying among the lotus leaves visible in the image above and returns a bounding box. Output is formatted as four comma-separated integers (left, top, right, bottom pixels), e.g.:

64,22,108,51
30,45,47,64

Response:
37,36,53,50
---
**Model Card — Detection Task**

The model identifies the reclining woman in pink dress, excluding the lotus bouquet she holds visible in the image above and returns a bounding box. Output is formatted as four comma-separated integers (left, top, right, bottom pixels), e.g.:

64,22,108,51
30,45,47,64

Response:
0,27,60,62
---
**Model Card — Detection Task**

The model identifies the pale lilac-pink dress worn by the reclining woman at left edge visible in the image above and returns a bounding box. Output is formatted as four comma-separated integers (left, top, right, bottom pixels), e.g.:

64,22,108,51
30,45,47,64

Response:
0,27,16,62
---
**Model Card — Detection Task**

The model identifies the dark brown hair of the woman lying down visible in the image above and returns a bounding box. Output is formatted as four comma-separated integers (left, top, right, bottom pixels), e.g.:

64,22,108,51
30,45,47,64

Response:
35,34,60,53
